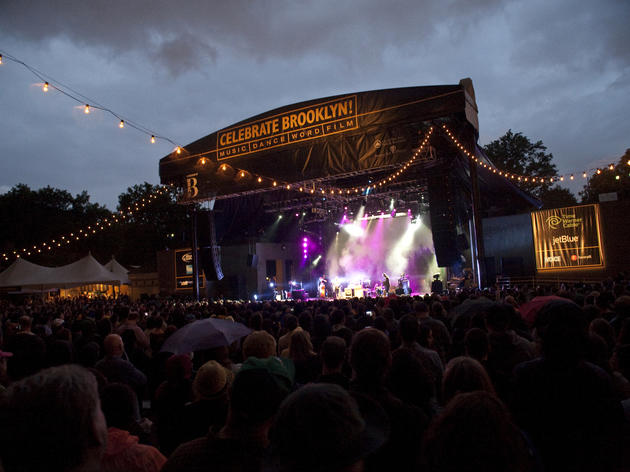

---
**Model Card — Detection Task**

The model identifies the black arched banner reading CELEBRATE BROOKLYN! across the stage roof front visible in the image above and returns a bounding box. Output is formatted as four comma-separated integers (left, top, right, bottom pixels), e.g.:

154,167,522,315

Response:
160,80,476,201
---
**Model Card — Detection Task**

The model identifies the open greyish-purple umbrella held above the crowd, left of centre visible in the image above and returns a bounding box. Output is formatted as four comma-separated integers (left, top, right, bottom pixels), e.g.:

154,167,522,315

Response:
161,318,252,354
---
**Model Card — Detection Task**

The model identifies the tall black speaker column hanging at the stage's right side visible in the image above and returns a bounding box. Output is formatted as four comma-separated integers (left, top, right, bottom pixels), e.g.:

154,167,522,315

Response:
427,172,460,267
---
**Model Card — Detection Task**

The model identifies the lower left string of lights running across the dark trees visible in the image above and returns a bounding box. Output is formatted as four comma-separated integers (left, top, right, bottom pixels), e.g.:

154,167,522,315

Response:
2,187,170,261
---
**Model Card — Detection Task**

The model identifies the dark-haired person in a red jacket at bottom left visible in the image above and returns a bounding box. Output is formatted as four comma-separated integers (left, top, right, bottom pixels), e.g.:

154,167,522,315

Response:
100,382,166,472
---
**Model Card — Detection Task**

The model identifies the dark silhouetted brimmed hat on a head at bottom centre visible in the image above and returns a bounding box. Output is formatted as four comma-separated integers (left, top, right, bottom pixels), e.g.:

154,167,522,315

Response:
270,383,389,471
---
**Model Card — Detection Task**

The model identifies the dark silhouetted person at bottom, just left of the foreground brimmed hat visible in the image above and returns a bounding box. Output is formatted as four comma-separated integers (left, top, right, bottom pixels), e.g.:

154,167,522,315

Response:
162,357,294,472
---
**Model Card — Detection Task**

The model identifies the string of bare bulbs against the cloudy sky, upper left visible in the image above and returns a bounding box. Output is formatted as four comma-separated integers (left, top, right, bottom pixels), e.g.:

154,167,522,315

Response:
0,51,181,149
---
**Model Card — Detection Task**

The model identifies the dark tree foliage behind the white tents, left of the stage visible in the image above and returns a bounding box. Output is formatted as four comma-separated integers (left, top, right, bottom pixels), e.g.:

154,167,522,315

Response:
0,182,193,270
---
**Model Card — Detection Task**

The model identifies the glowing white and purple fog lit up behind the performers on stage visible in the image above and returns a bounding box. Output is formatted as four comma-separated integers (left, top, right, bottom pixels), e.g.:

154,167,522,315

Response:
326,208,440,293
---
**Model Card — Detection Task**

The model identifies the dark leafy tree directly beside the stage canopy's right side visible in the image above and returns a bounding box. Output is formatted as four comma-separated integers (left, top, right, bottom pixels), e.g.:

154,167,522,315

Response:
483,129,577,208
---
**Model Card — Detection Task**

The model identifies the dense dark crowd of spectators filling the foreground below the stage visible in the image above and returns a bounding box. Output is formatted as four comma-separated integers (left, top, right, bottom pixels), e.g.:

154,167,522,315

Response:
0,274,630,472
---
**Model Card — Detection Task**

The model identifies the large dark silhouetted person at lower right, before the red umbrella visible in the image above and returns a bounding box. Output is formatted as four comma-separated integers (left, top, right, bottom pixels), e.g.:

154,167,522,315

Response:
513,301,623,471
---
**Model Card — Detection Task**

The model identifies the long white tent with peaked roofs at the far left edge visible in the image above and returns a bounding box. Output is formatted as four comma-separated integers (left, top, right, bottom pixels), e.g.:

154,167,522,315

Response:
0,254,129,290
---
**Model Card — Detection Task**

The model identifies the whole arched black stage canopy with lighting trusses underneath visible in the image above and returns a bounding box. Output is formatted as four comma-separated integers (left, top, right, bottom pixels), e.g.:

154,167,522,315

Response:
159,79,539,274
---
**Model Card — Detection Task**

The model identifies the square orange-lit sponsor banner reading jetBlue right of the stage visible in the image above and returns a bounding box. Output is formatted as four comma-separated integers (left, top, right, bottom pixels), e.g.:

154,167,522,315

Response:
531,205,604,271
